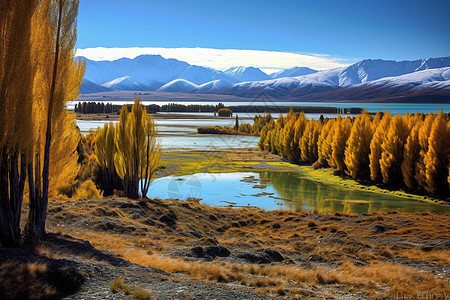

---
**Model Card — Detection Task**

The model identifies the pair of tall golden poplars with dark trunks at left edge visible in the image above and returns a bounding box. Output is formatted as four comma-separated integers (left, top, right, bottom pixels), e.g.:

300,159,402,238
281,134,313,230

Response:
0,0,85,247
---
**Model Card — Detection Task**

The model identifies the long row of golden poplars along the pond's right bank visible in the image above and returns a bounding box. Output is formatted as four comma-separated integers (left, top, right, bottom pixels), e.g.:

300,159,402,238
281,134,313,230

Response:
258,111,450,195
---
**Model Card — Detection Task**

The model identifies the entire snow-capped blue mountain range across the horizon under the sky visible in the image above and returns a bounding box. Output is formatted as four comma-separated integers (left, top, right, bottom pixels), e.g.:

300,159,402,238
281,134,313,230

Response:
81,55,450,102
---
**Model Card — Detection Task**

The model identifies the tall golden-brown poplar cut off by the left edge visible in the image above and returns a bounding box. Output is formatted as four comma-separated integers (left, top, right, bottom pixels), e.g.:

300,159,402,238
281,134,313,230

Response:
0,0,38,247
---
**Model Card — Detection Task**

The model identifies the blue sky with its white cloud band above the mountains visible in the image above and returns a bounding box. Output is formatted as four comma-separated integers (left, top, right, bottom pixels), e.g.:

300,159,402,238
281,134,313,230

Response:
77,0,450,73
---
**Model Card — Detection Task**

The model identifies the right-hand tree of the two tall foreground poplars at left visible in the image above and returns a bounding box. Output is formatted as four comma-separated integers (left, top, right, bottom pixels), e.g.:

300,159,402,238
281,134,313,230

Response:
25,0,84,242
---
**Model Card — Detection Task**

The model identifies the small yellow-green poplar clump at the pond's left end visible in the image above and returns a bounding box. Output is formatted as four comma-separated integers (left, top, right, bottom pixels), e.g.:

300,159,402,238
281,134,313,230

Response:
94,98,161,199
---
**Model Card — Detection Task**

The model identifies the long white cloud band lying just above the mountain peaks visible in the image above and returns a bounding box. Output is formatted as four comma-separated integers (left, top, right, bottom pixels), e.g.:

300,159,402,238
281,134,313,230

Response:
77,47,352,74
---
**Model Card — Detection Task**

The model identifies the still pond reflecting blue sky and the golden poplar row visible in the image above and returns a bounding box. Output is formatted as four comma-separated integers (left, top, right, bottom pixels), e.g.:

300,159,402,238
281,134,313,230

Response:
147,171,450,213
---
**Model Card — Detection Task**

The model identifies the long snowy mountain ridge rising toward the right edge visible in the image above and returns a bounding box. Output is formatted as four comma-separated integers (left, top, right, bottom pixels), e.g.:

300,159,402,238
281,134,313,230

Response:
213,57,450,97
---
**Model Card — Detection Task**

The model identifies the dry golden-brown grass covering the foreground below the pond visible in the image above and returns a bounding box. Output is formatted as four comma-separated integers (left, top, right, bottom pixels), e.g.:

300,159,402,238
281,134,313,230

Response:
44,199,450,297
